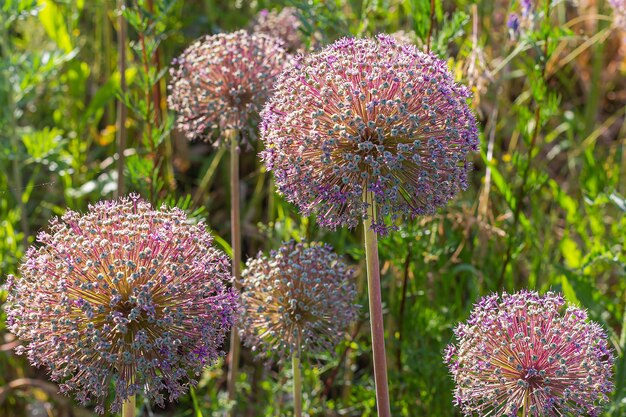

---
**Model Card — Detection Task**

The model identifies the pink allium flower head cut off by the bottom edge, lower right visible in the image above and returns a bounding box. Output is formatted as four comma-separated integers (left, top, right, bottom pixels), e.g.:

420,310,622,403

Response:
445,291,613,417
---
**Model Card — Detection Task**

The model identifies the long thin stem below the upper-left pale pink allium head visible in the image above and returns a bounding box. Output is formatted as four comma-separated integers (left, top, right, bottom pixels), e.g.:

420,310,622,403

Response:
228,130,241,416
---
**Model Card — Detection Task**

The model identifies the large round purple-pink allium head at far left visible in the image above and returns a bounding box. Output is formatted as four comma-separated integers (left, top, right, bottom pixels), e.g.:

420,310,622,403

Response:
7,195,238,413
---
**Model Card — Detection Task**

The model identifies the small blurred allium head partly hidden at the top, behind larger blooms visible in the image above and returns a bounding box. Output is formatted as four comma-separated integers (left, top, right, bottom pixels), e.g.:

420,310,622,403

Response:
251,7,304,53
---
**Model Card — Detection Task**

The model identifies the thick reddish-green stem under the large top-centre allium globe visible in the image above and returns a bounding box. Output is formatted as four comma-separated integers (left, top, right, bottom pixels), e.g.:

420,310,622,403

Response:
363,191,391,417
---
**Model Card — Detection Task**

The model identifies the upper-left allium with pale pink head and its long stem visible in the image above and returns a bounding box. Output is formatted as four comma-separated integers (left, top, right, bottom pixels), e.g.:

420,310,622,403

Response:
168,31,286,401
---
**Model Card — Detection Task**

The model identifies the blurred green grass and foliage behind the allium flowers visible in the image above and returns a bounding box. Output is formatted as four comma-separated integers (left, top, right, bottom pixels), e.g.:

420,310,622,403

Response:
0,0,626,417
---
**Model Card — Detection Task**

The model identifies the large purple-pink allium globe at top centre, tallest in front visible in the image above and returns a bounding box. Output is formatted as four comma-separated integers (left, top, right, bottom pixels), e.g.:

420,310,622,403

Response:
261,35,478,233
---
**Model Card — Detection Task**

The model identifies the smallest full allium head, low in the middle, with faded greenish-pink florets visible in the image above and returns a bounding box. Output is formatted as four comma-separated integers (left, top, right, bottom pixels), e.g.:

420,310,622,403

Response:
238,241,358,360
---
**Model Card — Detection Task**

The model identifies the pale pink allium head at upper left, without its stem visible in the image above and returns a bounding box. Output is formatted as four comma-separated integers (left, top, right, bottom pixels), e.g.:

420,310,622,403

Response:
167,30,287,143
